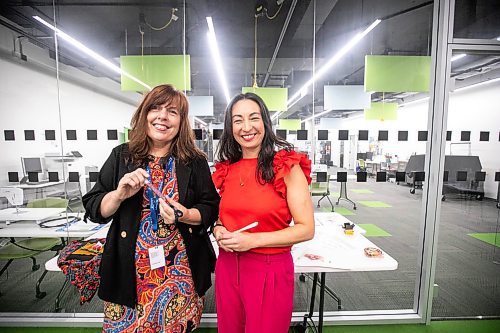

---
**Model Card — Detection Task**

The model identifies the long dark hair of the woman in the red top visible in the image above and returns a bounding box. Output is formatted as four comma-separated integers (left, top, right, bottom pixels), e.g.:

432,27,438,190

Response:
217,93,293,184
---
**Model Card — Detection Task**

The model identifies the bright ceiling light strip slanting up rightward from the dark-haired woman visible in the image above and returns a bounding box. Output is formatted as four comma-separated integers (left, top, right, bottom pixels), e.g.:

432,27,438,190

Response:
273,19,382,120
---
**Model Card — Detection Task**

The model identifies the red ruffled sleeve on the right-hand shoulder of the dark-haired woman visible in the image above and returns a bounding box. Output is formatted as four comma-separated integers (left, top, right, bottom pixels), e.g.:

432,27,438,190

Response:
273,149,311,198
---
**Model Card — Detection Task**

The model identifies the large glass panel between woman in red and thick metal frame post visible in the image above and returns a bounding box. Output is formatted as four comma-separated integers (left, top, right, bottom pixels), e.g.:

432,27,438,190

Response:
289,0,433,317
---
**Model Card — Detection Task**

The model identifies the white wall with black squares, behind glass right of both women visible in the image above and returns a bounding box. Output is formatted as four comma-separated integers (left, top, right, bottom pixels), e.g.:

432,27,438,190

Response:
316,81,500,198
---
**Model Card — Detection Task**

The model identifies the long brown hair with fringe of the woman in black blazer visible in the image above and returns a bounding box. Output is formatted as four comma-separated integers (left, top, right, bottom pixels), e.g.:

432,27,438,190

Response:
128,84,205,165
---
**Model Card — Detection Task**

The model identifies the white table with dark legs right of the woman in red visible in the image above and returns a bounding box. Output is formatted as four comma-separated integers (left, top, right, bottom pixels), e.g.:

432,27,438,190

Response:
292,213,398,333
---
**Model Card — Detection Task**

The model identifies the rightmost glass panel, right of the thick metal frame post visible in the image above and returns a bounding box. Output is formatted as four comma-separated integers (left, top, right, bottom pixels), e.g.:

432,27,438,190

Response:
432,51,500,318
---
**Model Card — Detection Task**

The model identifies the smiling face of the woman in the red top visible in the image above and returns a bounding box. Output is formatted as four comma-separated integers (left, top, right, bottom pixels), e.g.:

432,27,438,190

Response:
231,99,266,158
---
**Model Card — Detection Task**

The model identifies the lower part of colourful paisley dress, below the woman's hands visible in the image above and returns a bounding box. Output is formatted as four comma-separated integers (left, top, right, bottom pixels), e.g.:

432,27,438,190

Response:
103,215,204,333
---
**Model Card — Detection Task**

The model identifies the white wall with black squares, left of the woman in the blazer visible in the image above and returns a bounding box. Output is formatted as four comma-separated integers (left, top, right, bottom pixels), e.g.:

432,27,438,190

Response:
0,25,140,184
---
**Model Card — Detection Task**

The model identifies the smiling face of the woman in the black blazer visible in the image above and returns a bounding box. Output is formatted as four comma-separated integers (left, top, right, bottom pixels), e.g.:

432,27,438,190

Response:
146,103,181,155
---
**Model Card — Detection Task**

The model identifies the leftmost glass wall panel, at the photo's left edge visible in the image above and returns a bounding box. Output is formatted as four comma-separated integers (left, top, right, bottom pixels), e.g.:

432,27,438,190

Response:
0,2,72,313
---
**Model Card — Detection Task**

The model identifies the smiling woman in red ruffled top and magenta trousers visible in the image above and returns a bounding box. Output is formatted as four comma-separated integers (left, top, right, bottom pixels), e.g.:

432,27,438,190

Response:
212,93,314,333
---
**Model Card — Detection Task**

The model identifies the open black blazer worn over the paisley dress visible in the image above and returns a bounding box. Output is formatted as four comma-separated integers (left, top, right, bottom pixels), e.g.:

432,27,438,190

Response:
83,144,220,308
